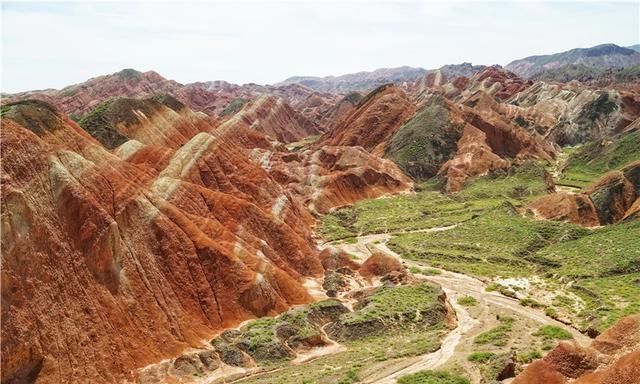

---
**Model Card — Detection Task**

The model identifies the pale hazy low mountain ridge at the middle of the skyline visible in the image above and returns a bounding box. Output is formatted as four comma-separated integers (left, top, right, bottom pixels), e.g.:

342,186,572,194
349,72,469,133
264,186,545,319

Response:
275,66,427,93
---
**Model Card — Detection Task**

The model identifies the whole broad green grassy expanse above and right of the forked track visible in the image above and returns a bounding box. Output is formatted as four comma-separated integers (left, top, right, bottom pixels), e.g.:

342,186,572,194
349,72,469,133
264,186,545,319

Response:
320,160,640,330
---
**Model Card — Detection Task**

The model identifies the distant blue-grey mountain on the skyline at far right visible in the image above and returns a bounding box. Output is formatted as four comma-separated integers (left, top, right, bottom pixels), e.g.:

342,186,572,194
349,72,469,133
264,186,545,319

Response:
505,44,640,78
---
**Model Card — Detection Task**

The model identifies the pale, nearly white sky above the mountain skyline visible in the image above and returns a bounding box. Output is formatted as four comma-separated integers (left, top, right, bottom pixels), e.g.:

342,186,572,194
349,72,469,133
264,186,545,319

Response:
1,0,640,92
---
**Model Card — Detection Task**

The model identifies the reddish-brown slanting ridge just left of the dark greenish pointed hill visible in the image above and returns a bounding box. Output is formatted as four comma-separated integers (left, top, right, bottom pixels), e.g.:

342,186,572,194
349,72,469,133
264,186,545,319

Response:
319,85,416,155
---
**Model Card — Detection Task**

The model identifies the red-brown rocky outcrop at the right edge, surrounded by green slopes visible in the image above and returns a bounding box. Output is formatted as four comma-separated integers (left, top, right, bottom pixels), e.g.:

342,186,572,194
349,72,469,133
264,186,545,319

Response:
529,161,640,227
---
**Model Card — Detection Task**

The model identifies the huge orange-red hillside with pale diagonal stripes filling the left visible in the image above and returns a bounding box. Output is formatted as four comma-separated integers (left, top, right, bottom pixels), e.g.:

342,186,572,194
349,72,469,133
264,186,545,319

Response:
1,103,323,383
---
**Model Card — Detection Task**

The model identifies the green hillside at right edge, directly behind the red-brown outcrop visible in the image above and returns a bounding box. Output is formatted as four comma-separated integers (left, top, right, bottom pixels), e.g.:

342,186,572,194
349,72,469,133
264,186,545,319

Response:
560,130,640,187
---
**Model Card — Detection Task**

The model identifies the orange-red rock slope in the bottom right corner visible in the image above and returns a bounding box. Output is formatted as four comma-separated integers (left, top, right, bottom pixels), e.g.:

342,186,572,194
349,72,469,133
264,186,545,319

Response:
513,315,640,384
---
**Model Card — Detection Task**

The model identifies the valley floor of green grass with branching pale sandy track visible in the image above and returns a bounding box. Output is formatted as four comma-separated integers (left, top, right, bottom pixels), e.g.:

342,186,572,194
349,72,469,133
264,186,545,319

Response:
138,160,640,384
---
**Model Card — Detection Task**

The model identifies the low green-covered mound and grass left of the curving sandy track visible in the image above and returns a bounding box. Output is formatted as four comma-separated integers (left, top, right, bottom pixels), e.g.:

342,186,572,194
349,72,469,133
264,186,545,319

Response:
234,283,447,384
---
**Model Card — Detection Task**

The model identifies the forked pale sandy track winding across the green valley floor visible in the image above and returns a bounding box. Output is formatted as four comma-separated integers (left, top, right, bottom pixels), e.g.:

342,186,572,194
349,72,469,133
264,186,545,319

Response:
333,225,591,384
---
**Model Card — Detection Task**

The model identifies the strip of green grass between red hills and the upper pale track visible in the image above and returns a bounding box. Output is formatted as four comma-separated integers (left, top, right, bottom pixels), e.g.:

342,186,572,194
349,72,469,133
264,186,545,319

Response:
319,163,547,240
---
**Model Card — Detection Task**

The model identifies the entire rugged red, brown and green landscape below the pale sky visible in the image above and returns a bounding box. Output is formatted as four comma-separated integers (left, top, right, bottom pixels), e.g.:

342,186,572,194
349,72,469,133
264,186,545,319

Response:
0,44,640,384
